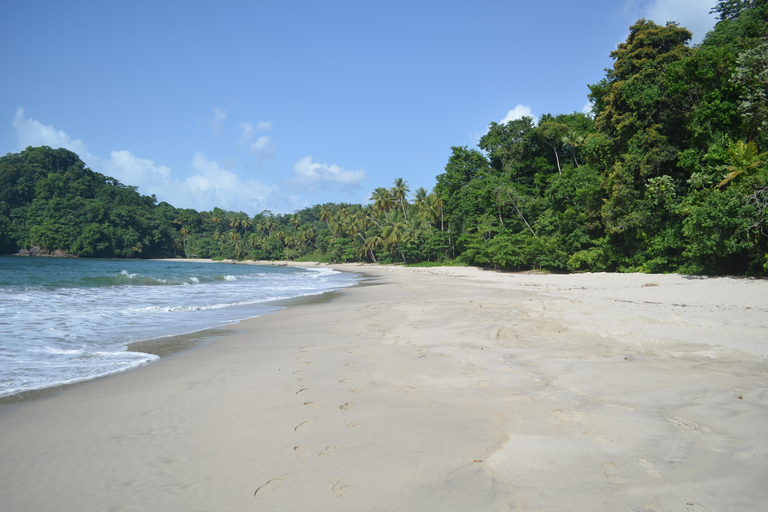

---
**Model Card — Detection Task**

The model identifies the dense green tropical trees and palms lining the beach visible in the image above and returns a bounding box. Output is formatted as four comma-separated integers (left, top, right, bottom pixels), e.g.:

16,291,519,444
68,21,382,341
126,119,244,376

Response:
0,0,768,275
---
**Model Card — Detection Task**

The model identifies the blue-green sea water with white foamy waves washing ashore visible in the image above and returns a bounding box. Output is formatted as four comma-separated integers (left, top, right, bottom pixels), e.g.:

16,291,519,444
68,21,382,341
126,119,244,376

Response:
0,257,359,396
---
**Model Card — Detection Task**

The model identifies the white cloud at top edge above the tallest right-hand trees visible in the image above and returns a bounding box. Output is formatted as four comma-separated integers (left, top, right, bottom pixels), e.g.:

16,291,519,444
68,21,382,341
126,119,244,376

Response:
623,0,717,44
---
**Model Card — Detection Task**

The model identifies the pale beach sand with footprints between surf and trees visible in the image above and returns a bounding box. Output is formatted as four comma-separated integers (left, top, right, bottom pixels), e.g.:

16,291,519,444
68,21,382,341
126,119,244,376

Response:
0,265,768,511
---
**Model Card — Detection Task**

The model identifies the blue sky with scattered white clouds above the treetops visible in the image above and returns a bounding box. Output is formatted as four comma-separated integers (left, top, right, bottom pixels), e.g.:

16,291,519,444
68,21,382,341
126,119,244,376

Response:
0,0,716,216
